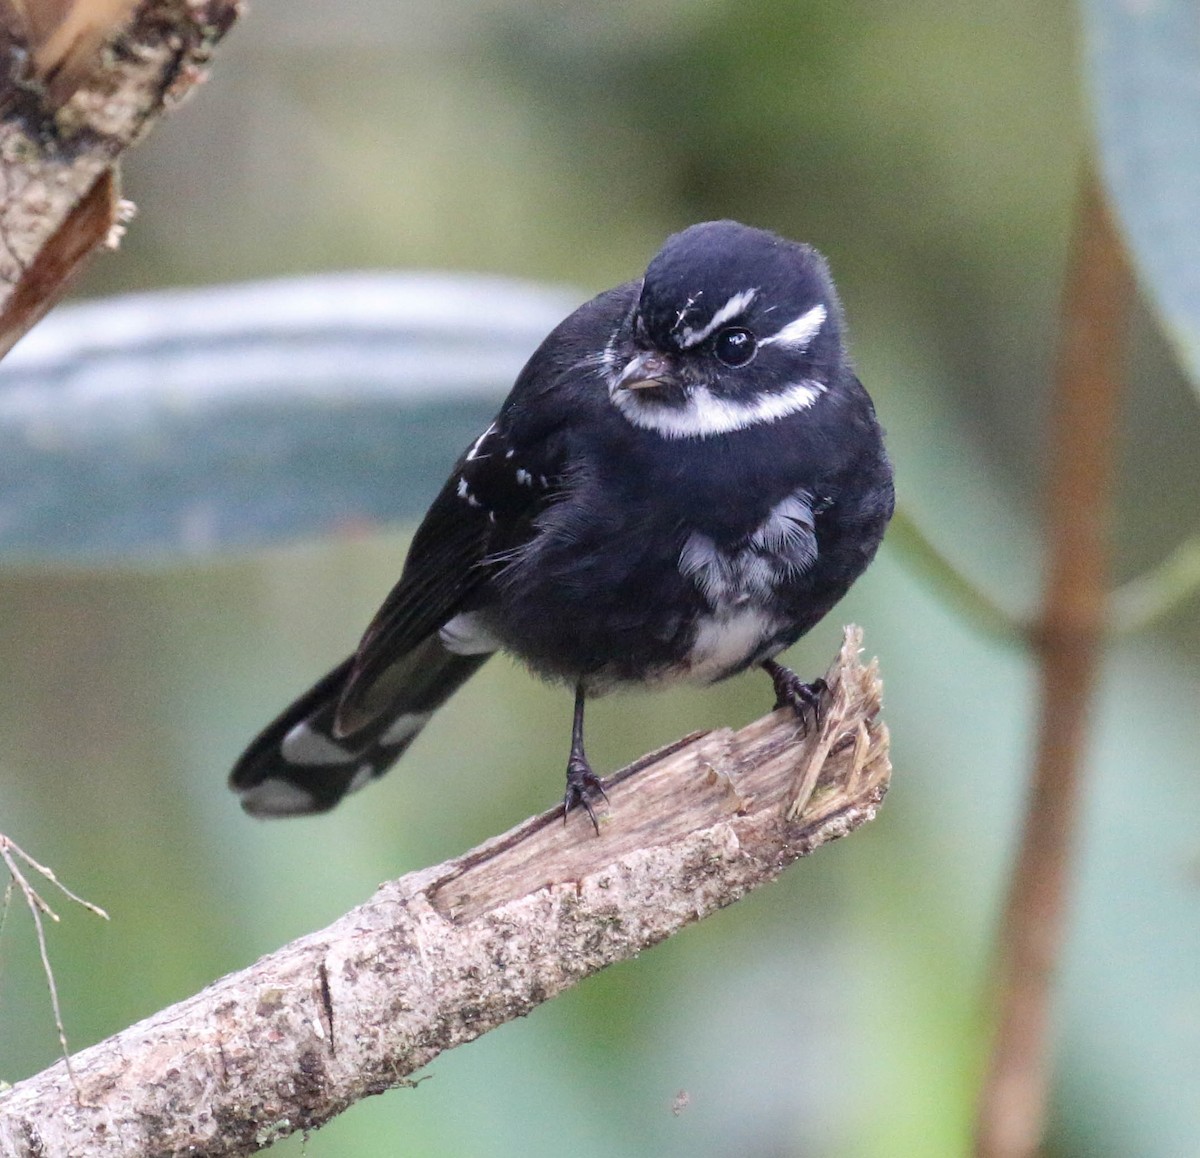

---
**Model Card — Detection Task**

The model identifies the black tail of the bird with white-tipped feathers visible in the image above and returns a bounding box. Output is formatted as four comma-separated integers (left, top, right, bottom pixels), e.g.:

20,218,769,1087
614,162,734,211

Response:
229,635,488,817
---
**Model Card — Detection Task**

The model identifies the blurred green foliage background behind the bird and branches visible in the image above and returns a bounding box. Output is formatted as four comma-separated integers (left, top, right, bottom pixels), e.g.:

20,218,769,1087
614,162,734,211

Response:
0,0,1200,1158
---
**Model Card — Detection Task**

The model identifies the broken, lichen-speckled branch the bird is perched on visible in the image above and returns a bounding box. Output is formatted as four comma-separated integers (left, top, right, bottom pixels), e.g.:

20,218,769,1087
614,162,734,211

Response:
0,628,890,1158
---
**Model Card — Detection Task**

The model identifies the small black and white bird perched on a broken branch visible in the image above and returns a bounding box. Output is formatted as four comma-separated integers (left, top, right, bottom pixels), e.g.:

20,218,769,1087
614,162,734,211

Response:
230,221,893,823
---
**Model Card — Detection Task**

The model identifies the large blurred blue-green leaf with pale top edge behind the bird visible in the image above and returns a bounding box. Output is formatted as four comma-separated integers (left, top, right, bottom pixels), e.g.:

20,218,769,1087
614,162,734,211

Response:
0,274,574,563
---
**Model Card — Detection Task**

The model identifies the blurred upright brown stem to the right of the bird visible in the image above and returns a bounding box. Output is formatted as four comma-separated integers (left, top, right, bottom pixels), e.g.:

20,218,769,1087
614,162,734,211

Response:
976,171,1133,1158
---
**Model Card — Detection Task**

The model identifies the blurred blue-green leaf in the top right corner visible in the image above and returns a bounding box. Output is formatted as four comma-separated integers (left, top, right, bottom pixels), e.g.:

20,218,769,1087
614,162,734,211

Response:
1084,0,1200,386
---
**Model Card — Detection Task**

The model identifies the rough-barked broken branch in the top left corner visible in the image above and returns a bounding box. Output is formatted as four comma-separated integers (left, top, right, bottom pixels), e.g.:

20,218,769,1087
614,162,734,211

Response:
0,0,240,355
